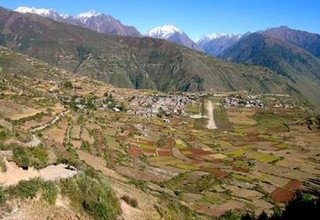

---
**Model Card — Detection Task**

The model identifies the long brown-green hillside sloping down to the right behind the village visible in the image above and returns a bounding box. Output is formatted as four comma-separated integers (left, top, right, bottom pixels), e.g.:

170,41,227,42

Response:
0,6,299,102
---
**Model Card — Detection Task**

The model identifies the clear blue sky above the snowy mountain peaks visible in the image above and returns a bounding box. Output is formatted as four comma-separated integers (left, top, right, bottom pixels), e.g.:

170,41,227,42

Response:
0,0,320,39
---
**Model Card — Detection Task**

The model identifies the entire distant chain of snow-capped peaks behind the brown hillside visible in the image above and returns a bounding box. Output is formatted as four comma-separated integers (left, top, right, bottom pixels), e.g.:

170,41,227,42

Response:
15,6,242,52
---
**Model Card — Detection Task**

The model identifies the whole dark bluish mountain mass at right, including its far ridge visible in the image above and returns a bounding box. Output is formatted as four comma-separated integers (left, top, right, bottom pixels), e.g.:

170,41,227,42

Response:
219,26,320,104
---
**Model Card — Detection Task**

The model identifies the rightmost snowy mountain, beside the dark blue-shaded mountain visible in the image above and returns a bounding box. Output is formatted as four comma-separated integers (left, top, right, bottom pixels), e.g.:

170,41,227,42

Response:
197,33,244,57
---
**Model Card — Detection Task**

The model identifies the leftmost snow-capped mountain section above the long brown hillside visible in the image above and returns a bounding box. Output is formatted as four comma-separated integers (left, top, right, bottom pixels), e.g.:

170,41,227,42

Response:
16,7,141,37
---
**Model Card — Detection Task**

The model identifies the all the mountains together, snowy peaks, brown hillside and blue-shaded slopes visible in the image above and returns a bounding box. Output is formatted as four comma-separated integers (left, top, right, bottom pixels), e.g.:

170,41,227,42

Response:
0,5,320,105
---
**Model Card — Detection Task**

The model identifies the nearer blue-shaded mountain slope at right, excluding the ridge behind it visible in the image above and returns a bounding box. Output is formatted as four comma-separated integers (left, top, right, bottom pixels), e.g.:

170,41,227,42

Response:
220,32,320,105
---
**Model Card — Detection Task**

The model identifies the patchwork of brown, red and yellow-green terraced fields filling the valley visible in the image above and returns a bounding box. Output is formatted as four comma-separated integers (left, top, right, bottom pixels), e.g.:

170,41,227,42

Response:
0,62,320,219
